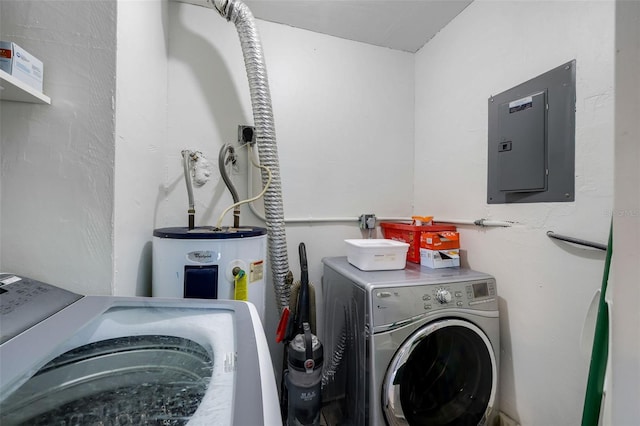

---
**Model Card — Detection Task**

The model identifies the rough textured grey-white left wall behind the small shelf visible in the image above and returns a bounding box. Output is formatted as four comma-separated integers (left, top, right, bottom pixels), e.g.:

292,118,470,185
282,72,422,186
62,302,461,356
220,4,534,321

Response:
0,1,116,294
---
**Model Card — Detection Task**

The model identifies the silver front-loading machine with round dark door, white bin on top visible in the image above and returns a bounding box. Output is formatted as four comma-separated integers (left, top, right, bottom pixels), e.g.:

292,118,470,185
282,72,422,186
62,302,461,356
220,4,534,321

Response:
320,257,500,426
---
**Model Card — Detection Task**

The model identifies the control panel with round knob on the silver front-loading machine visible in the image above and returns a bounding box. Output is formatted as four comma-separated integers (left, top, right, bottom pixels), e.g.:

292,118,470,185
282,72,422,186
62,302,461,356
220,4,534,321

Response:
371,278,498,327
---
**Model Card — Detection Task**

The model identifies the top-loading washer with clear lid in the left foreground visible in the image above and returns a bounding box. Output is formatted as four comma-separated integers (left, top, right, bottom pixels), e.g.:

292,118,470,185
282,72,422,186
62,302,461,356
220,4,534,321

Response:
0,274,282,426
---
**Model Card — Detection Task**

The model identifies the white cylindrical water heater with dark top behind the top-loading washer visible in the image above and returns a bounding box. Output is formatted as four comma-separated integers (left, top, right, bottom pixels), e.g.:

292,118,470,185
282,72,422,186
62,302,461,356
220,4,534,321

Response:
152,227,267,324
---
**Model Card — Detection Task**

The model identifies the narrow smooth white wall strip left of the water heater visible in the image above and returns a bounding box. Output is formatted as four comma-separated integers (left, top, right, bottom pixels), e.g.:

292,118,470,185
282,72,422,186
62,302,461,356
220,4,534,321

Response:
113,1,168,296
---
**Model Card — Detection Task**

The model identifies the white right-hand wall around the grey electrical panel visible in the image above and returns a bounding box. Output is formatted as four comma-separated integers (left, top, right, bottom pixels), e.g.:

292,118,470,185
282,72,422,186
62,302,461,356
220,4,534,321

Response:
414,0,614,426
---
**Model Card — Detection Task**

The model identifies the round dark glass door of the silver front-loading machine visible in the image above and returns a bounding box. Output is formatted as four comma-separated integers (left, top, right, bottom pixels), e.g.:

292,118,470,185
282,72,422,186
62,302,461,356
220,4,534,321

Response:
382,319,497,426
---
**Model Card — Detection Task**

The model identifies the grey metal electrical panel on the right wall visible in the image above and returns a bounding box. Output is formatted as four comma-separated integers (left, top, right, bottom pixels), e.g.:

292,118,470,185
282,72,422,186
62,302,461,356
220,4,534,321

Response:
487,60,576,204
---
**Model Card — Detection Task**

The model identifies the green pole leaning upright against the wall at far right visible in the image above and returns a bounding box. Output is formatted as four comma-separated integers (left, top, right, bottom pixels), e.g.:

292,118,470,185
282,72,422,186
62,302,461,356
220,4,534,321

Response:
582,222,613,426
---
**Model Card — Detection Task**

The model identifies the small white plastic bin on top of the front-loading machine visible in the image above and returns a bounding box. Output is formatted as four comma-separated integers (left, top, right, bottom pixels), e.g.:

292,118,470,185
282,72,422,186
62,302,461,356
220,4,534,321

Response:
344,239,409,271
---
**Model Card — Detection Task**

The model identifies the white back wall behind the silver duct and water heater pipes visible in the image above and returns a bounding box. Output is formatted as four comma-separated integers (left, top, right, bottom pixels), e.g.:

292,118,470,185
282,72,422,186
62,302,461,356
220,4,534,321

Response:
165,3,414,364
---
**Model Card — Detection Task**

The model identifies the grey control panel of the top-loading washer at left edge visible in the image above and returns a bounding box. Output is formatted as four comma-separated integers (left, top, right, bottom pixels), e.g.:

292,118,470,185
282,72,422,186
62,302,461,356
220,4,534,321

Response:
0,274,82,344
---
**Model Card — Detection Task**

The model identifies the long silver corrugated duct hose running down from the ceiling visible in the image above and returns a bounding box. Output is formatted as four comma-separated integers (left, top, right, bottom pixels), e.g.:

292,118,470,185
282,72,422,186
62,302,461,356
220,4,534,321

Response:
216,0,291,311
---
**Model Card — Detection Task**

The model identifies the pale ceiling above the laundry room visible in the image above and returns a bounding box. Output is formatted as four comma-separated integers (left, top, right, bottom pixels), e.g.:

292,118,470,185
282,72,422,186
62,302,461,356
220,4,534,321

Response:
244,0,472,52
